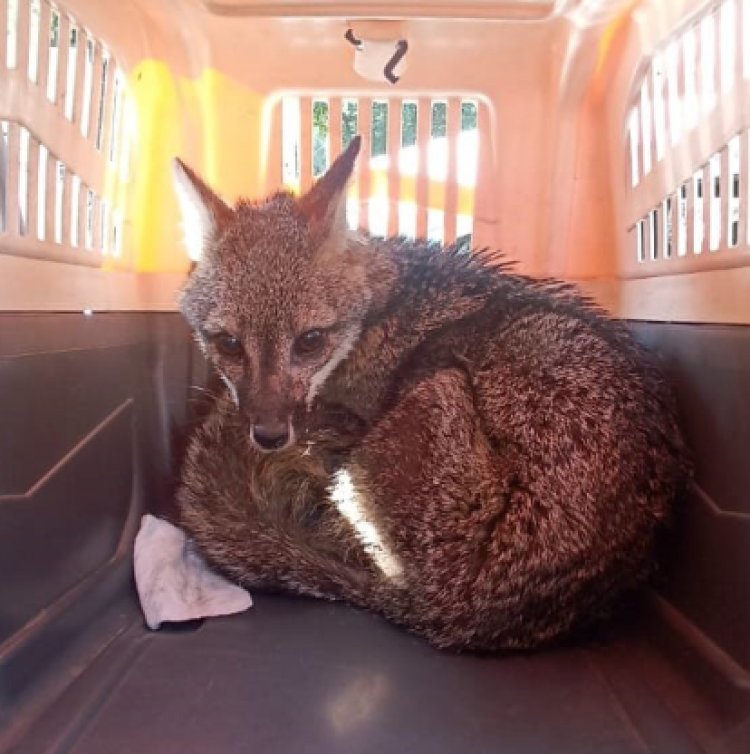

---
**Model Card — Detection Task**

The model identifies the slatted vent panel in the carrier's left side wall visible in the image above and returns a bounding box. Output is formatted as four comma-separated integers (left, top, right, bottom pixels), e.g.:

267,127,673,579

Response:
0,0,135,265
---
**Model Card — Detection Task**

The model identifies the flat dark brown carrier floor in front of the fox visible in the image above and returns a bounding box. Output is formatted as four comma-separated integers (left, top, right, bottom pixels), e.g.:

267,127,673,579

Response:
7,596,712,754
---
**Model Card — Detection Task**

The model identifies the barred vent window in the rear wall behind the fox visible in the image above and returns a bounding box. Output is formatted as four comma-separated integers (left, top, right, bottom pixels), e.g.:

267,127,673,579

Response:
280,95,481,243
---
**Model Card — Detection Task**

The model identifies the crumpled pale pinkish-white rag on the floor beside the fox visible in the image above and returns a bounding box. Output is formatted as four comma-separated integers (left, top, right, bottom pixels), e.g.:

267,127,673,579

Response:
134,514,253,629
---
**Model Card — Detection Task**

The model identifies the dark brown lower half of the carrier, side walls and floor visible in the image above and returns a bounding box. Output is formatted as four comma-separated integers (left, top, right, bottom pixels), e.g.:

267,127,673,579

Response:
0,314,750,754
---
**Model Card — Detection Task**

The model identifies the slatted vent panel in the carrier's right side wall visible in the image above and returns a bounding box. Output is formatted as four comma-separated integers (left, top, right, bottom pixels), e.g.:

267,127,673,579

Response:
625,0,750,272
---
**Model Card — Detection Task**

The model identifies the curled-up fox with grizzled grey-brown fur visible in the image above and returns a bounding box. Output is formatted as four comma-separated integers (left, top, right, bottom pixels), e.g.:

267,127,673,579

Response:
173,135,689,650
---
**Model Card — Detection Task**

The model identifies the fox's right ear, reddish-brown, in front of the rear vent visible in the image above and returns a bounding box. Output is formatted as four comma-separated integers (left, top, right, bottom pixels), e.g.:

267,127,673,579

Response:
299,136,362,241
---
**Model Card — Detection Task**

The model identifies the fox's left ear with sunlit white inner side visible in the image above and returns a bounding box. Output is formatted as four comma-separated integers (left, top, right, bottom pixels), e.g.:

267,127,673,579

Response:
172,158,234,262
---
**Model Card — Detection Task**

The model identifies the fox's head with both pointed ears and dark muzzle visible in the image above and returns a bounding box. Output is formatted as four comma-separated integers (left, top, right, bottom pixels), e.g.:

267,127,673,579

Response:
175,139,369,451
